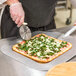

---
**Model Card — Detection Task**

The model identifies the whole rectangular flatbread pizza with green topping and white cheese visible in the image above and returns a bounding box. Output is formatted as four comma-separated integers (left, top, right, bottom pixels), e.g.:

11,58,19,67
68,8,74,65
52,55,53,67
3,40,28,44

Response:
12,34,72,63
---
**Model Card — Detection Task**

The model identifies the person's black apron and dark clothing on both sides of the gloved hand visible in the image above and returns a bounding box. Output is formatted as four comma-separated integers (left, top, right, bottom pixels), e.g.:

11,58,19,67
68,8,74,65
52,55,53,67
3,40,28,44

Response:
1,0,57,38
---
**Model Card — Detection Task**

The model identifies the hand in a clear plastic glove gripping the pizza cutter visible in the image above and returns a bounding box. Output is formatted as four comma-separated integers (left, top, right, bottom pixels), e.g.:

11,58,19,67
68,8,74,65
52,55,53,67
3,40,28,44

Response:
10,2,25,27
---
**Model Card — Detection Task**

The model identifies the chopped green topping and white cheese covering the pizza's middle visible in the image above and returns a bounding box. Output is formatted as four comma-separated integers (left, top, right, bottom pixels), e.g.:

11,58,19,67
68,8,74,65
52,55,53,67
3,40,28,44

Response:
18,34,67,59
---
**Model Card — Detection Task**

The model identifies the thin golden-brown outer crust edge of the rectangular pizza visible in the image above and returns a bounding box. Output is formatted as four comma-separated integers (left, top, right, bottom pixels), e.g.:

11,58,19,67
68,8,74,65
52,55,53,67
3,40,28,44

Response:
12,34,72,63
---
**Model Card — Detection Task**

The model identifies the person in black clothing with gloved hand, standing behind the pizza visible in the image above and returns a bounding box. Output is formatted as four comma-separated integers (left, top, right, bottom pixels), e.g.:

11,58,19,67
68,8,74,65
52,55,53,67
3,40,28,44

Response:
1,0,74,38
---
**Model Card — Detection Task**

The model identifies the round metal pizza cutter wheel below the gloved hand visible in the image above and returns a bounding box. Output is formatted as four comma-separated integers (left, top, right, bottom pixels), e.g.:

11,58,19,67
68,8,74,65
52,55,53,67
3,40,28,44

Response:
19,22,31,40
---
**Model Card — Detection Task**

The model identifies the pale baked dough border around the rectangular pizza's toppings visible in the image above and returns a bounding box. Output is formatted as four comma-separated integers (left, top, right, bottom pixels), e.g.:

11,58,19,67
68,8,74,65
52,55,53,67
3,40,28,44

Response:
12,34,72,63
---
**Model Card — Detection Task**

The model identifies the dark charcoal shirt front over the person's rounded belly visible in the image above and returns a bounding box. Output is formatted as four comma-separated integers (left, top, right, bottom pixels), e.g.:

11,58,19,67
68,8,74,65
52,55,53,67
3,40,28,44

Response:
20,0,57,27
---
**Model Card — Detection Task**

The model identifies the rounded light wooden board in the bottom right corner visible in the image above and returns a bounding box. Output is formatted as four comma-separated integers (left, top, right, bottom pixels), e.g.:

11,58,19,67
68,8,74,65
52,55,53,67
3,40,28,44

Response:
46,62,76,76
